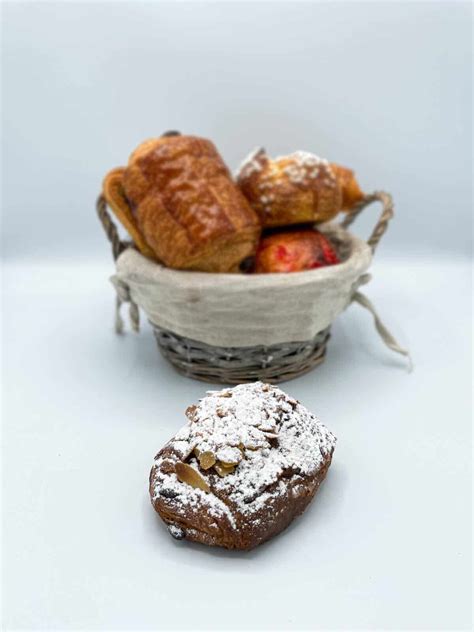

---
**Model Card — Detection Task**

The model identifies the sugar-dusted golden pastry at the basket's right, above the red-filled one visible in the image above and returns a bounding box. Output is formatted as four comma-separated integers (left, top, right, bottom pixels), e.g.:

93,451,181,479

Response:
237,149,364,227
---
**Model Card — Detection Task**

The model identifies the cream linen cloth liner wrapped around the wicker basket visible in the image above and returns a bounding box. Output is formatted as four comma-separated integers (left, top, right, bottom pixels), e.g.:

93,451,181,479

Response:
113,224,372,347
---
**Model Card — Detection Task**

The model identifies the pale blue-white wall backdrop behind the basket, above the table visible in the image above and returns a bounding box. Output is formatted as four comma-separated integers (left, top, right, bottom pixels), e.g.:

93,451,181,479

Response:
3,1,472,259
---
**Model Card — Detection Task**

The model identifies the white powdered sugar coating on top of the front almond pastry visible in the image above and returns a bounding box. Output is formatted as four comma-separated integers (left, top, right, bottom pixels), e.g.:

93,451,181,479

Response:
153,382,336,527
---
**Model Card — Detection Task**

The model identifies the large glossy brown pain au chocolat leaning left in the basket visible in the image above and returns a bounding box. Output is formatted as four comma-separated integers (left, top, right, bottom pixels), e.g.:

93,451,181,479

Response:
117,135,260,272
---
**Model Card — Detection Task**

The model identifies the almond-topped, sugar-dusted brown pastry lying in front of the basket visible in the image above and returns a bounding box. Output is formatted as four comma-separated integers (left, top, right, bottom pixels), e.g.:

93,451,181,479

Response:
150,382,336,549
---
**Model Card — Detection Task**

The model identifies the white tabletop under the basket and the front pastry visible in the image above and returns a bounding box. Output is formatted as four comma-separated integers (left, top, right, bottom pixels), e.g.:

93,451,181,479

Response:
2,259,471,630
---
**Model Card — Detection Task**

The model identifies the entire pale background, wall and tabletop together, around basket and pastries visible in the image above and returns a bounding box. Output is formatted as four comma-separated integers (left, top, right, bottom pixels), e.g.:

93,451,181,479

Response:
1,1,472,632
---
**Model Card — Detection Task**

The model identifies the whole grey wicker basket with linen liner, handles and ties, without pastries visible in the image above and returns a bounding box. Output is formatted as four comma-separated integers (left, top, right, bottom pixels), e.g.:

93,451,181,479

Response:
96,192,408,384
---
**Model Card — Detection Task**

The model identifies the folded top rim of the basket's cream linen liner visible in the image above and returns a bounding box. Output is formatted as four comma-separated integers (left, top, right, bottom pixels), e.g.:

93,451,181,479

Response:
116,223,372,290
